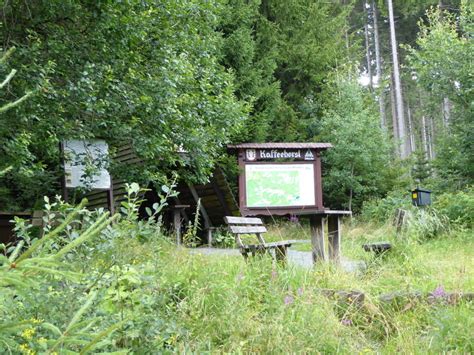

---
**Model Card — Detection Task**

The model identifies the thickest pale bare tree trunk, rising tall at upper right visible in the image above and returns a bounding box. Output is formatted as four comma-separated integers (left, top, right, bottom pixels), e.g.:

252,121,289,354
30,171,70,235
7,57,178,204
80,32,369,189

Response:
387,0,408,159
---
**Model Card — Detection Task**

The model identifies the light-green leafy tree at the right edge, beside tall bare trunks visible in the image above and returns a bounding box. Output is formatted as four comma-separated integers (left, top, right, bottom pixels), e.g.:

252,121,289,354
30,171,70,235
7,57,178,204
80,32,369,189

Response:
409,1,474,190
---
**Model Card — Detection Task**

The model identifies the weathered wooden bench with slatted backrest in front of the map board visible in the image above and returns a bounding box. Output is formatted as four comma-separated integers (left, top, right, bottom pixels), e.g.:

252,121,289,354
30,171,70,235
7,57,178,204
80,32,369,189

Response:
224,216,291,263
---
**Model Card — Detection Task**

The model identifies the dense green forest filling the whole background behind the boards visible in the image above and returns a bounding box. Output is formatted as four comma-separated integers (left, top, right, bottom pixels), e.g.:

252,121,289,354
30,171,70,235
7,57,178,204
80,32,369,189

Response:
0,0,474,211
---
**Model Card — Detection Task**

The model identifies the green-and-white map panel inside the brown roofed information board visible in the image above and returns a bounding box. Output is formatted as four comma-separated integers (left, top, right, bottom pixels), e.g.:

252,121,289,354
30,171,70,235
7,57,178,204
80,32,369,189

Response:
245,163,315,207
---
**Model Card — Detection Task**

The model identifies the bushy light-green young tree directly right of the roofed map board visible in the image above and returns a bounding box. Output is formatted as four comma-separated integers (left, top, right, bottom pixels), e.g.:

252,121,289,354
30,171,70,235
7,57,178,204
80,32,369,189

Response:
318,74,399,211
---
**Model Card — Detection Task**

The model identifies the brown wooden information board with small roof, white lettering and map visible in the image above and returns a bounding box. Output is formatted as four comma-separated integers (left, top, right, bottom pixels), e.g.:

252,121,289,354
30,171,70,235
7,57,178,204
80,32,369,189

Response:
229,143,331,216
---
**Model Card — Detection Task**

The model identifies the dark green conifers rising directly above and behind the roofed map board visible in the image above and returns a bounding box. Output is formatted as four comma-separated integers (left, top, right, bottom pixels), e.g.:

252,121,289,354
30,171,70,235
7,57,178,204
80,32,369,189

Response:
221,0,354,142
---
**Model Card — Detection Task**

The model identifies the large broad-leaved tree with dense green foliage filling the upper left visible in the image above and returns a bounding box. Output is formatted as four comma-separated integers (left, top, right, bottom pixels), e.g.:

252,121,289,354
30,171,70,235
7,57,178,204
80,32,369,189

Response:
0,0,247,209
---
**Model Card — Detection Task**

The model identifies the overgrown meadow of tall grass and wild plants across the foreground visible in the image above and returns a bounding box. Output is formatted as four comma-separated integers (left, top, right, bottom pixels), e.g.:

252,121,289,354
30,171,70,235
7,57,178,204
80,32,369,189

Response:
0,186,474,354
